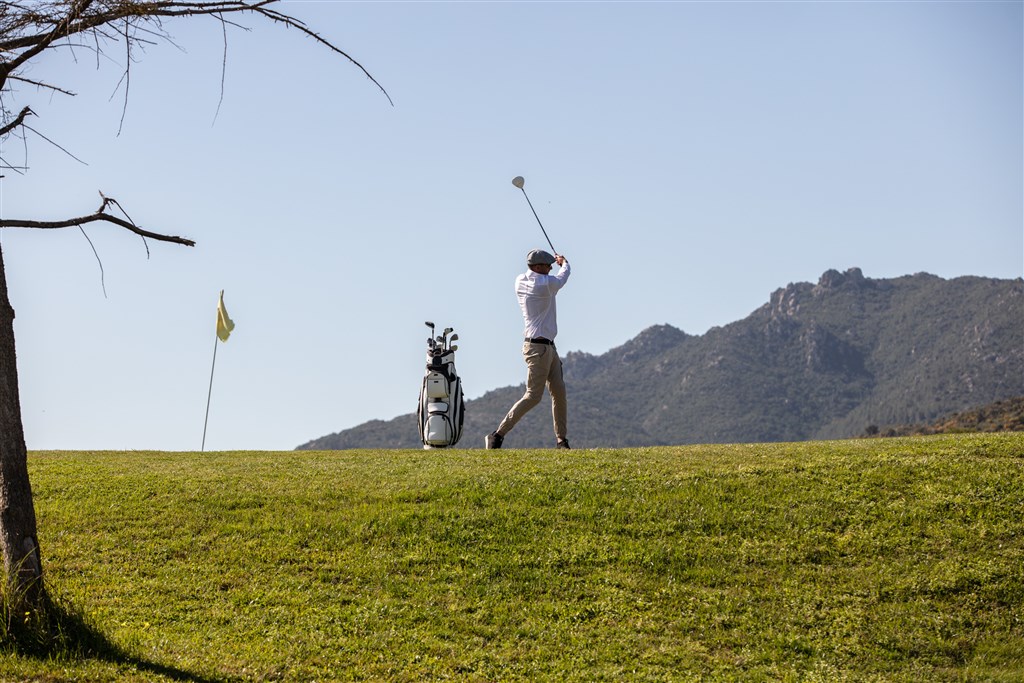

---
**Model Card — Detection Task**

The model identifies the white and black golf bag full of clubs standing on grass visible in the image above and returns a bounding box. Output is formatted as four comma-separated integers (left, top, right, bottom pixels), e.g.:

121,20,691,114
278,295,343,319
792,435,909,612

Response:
417,323,465,449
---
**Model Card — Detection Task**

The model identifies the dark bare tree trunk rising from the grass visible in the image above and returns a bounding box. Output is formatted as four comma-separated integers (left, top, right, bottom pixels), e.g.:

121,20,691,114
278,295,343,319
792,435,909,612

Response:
0,240,43,604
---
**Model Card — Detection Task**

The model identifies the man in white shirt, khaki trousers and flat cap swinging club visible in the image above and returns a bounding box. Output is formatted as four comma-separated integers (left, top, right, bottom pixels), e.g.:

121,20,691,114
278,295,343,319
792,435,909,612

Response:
483,249,569,449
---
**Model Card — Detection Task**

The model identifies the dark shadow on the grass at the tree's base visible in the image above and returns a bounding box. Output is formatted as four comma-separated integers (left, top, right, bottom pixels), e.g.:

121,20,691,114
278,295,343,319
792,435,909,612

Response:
0,590,225,683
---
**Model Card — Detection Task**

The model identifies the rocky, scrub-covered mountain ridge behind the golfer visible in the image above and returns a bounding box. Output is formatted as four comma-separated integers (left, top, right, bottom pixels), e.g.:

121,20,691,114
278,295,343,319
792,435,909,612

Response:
298,268,1024,450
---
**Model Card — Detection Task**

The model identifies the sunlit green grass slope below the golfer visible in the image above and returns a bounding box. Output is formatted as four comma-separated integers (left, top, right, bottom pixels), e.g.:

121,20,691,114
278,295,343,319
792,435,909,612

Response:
0,433,1024,681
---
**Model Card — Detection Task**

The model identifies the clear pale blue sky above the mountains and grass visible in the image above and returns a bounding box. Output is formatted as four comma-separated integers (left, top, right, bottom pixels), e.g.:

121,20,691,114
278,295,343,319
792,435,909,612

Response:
0,1,1024,451
